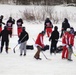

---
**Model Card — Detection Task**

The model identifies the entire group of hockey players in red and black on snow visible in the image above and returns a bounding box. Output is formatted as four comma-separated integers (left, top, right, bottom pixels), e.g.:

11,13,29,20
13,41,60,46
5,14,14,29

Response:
0,15,76,61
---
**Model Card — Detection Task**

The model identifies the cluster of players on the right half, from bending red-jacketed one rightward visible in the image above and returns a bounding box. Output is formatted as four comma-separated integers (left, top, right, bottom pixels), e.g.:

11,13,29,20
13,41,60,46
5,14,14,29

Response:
34,18,76,61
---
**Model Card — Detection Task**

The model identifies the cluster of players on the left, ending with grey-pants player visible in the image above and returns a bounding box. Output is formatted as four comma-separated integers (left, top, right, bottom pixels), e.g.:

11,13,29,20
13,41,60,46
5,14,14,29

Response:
0,15,29,56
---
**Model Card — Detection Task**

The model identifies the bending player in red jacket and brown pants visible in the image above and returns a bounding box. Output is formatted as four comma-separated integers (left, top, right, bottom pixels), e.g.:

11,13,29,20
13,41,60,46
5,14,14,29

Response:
34,31,45,59
